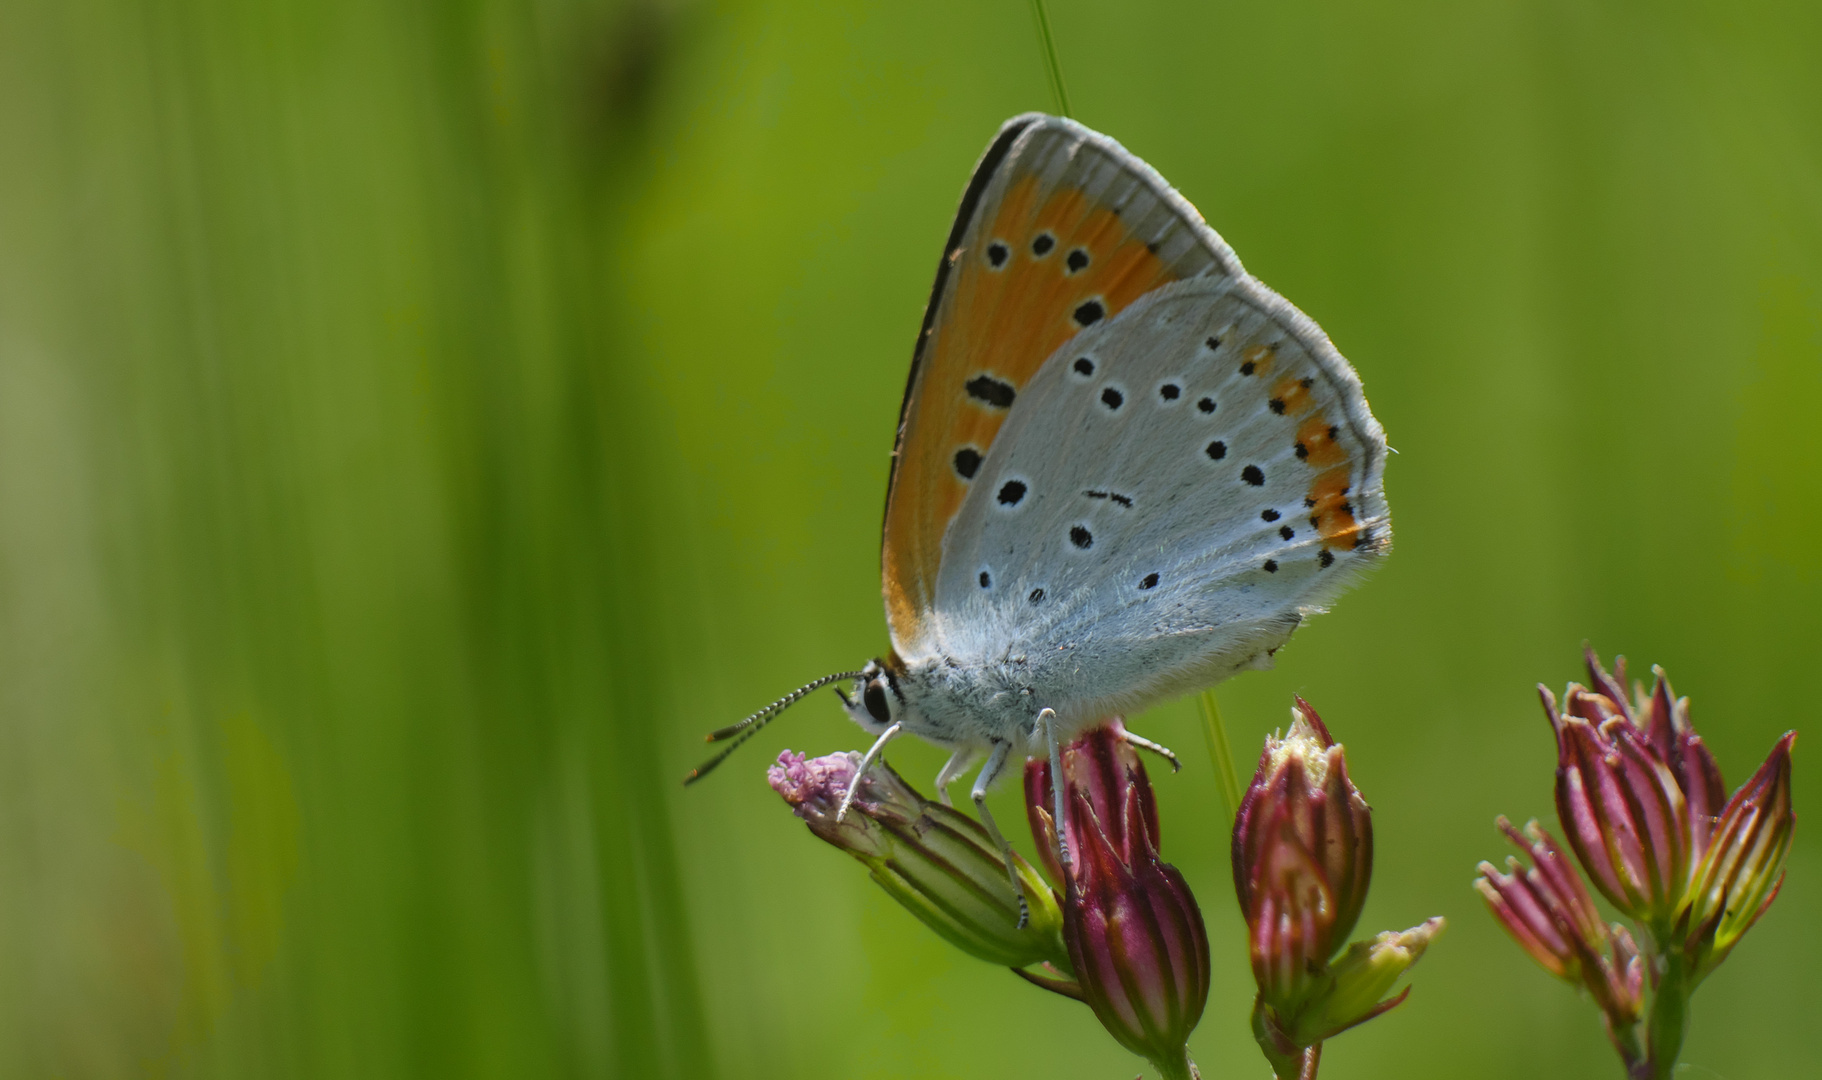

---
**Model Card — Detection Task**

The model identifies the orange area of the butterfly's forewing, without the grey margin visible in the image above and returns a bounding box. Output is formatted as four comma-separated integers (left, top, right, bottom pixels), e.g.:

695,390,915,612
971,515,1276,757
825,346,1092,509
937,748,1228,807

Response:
882,175,1181,641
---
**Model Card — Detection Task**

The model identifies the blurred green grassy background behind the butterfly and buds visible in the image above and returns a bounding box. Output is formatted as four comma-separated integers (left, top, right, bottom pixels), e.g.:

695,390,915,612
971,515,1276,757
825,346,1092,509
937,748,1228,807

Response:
0,0,1822,1080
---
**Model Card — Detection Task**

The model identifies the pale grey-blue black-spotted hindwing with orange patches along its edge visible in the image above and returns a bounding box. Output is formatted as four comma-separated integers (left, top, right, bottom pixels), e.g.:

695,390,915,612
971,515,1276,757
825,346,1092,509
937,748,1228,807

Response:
933,275,1390,710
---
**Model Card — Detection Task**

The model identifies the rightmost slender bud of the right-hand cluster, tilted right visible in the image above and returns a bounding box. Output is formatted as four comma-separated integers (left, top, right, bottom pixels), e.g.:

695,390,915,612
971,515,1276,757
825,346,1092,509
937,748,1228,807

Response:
1684,732,1796,980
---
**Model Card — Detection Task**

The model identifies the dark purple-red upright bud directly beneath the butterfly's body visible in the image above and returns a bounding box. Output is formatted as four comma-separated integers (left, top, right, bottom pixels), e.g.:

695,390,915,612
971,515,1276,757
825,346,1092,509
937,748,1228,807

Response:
1026,719,1208,1076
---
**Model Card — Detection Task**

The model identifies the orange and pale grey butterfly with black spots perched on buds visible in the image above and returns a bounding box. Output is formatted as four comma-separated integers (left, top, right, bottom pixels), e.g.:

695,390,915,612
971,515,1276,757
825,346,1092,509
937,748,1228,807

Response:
685,113,1392,914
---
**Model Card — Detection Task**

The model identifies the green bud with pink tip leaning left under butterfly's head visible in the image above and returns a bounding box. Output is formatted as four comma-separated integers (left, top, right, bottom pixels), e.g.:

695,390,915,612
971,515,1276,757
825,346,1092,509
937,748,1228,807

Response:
767,750,1070,973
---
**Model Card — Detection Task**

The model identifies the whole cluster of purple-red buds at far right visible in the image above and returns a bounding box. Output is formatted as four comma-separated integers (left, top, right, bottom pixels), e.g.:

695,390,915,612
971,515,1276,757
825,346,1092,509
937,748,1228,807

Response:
1474,650,1796,1078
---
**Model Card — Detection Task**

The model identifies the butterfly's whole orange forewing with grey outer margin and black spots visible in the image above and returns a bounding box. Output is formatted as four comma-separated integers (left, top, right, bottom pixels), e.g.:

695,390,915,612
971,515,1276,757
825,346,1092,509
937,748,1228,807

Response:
882,115,1243,654
